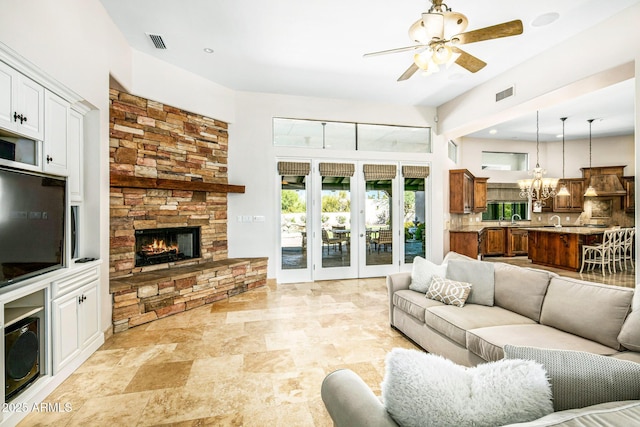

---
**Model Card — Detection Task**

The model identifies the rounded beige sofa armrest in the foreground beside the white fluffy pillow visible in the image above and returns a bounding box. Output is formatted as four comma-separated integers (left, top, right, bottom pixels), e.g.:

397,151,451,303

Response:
321,369,398,427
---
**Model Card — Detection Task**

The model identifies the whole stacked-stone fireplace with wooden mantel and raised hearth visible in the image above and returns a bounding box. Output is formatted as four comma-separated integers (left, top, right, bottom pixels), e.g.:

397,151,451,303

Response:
109,89,267,332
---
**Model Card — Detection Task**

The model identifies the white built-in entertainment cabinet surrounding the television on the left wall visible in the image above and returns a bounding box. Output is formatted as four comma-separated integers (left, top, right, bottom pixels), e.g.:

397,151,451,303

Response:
0,53,104,427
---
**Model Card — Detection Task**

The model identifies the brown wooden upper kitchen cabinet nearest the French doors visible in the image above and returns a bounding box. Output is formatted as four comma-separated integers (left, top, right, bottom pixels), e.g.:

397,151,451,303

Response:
449,169,488,214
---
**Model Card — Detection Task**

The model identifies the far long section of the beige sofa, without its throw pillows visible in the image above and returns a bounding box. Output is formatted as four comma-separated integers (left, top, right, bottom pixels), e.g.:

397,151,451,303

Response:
387,252,640,366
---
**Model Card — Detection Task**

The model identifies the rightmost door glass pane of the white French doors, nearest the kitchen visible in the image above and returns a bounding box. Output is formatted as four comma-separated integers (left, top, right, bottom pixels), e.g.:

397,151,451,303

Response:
404,178,426,263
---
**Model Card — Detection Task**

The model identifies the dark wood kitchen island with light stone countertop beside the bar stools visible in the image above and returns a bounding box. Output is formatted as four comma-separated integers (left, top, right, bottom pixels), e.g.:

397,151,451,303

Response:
525,226,606,271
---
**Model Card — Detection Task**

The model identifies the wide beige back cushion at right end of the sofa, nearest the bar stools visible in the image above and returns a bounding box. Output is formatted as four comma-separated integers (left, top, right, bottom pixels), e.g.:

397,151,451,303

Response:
540,276,633,350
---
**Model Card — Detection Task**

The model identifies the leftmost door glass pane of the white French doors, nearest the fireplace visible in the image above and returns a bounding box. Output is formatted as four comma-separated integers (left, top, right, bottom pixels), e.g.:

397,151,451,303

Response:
280,175,307,270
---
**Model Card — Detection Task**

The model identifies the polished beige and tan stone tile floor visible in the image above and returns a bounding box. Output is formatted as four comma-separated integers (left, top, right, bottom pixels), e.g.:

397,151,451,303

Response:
20,257,635,427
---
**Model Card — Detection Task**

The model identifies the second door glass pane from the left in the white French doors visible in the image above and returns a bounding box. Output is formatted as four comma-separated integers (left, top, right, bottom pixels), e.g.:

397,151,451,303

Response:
320,176,351,268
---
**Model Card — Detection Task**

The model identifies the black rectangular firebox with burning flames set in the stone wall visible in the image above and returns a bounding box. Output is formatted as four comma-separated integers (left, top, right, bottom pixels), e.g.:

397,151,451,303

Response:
135,227,200,267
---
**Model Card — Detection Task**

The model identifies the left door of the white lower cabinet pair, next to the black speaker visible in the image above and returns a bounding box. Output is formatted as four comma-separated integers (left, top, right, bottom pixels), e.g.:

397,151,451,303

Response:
52,289,82,375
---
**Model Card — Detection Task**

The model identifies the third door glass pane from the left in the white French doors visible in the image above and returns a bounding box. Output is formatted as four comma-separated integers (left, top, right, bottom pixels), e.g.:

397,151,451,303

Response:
365,179,393,265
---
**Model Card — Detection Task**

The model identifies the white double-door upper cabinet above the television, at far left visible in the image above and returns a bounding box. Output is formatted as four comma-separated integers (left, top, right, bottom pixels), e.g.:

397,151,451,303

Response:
0,62,44,141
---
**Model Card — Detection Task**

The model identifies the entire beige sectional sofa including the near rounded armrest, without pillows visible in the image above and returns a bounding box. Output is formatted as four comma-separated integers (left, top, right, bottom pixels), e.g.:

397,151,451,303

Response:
322,252,640,427
